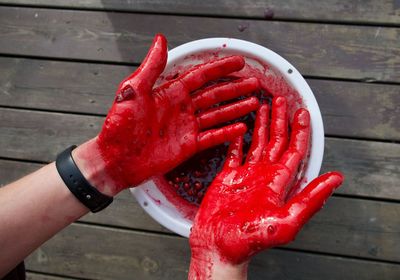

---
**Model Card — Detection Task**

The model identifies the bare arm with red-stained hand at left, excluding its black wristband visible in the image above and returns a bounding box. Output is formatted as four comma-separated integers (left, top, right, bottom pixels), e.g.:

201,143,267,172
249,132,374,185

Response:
0,32,258,277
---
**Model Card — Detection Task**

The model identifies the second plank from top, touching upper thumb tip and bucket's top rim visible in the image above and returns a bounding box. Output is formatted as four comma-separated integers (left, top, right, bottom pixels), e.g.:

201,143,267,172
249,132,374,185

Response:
0,6,400,82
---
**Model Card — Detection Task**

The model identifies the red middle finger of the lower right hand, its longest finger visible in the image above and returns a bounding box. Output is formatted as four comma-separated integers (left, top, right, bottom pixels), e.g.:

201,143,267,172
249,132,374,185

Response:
263,96,288,163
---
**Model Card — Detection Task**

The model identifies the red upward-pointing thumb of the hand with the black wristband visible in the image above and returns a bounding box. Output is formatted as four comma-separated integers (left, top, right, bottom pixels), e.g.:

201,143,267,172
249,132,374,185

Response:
120,34,168,92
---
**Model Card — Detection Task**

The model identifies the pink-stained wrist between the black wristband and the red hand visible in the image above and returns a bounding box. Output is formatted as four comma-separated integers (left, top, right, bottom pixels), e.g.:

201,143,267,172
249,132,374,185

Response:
72,139,119,197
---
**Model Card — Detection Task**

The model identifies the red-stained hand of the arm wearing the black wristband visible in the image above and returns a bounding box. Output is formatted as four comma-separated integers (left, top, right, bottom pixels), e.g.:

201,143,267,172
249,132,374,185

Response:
72,35,259,195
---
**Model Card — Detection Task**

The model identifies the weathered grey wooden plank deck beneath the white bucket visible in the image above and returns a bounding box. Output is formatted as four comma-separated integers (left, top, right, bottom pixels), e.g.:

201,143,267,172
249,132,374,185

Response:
0,0,400,280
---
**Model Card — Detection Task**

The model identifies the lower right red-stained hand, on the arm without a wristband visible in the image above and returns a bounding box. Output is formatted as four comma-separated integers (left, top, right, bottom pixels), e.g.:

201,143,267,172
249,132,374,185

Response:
189,97,343,279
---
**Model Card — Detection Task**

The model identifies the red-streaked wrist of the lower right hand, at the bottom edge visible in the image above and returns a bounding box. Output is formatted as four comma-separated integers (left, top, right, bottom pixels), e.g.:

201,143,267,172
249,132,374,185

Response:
188,249,248,280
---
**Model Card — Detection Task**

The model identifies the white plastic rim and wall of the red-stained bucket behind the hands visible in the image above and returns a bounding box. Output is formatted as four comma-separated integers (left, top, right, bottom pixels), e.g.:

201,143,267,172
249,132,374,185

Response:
131,38,324,237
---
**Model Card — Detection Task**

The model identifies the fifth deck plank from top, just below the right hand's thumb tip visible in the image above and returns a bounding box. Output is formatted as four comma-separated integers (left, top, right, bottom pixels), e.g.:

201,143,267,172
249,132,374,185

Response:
0,165,400,262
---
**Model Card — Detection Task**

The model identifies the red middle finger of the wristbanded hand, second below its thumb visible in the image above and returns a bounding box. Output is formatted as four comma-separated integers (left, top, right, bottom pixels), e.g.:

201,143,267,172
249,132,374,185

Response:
192,78,259,110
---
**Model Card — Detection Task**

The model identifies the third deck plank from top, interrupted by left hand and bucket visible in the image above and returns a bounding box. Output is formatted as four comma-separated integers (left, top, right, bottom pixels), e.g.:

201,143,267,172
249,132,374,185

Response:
0,57,400,141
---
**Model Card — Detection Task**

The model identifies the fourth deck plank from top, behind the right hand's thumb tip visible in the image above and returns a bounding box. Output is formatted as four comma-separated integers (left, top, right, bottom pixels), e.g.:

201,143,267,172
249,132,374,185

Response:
0,108,400,200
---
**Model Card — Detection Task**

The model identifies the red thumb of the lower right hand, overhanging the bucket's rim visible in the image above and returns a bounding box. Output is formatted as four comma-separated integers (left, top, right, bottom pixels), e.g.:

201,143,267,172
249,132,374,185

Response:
284,172,343,227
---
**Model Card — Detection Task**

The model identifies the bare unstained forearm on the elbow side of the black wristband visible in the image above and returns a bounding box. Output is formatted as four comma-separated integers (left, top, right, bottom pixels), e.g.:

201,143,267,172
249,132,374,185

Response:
0,162,89,278
